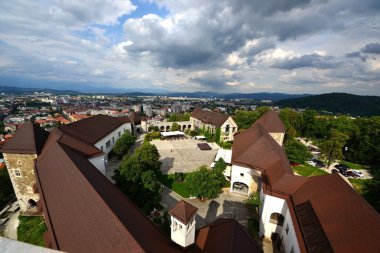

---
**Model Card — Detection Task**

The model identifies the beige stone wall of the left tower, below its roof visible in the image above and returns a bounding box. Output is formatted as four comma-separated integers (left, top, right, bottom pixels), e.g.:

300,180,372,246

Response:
4,153,39,212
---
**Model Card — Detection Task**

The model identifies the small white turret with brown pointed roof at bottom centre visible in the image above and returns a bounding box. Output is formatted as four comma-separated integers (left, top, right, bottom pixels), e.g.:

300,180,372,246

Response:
169,200,198,248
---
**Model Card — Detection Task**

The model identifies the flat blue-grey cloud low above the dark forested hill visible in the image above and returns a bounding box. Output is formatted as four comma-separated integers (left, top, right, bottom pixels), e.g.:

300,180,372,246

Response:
273,53,338,69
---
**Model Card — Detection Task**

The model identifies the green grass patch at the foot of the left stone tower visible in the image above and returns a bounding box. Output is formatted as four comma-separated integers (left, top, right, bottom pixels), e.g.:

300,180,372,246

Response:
17,216,47,246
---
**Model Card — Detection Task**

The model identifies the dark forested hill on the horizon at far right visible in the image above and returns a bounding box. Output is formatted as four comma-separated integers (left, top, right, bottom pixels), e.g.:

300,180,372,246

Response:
276,93,380,116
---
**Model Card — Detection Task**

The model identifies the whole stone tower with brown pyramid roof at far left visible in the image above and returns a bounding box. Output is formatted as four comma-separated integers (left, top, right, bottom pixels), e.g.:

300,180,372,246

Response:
1,123,49,212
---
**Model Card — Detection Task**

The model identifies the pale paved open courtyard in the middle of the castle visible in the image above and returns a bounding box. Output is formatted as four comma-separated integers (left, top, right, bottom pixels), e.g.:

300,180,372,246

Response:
151,139,219,174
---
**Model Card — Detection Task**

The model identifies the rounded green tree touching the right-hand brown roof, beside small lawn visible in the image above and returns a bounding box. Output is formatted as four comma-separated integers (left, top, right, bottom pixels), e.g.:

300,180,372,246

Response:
284,138,313,163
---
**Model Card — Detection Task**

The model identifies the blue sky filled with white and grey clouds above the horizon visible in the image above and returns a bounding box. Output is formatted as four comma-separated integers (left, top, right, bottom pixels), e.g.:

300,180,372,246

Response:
0,0,380,95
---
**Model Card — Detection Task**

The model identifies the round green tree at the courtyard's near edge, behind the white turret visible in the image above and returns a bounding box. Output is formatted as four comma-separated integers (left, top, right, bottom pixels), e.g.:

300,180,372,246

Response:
186,165,224,199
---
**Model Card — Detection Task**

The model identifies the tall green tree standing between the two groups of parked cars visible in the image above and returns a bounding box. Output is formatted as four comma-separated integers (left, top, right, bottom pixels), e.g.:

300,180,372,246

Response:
319,129,349,166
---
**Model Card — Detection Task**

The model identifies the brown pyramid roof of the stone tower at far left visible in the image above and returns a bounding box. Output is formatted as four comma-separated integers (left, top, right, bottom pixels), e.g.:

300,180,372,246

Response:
1,122,49,155
